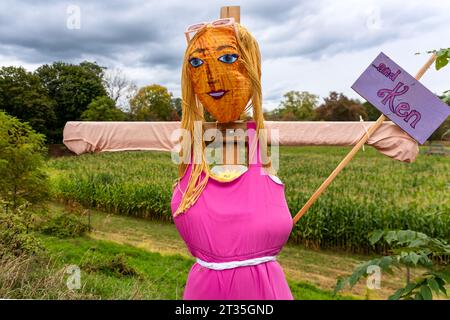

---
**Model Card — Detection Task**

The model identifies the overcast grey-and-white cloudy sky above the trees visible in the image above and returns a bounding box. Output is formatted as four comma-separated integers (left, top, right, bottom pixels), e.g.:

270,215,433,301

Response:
0,0,450,110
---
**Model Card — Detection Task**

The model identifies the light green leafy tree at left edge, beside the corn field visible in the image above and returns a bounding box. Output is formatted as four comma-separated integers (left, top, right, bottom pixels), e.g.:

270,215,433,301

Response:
0,111,49,211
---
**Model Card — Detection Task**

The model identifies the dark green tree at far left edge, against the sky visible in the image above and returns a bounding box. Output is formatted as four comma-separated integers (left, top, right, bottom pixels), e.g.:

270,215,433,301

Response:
0,67,56,136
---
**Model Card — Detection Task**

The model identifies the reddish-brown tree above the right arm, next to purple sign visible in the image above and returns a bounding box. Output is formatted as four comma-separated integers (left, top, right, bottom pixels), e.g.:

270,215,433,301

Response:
315,91,368,121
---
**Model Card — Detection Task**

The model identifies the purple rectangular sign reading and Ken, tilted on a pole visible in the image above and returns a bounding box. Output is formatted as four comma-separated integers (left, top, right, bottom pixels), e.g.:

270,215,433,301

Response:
352,53,450,144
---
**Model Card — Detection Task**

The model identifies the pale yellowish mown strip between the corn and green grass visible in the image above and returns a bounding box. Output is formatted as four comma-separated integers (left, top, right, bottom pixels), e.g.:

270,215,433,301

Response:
50,203,426,299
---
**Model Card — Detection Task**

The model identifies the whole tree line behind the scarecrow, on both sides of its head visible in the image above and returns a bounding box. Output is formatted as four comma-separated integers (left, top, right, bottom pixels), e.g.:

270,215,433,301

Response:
0,61,450,143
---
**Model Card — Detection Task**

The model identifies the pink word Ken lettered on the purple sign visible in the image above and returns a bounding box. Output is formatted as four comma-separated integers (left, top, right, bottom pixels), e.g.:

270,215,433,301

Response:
377,82,422,128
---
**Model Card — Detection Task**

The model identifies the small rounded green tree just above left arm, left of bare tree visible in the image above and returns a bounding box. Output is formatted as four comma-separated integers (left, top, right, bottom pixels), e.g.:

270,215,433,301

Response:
81,96,126,121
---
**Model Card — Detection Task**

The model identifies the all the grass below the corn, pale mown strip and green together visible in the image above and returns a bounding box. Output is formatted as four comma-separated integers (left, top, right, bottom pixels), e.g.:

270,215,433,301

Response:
42,203,440,300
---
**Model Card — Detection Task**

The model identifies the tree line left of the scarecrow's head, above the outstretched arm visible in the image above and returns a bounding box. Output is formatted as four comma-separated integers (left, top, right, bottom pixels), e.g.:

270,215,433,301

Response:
0,61,181,143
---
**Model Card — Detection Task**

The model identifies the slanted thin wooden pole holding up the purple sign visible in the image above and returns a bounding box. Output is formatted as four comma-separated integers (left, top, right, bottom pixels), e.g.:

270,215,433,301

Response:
293,53,436,224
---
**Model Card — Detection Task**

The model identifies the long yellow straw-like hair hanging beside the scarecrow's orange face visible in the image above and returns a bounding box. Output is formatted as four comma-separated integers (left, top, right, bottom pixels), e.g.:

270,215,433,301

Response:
174,23,267,216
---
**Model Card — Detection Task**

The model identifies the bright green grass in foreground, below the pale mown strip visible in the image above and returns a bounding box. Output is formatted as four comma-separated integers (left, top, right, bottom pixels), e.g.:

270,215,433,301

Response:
40,230,352,300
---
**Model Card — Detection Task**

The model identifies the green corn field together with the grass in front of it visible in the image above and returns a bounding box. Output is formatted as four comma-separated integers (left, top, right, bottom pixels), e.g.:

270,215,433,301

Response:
38,147,450,299
